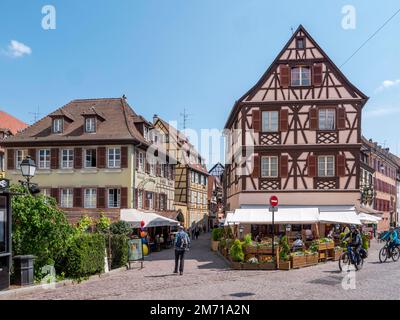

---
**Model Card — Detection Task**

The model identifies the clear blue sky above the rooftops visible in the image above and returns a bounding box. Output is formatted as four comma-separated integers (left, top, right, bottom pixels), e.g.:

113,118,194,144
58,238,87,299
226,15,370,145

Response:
0,0,400,158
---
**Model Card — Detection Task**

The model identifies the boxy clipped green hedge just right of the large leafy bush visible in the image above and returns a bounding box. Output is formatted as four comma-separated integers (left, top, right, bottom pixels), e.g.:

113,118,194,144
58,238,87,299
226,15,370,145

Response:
63,233,105,278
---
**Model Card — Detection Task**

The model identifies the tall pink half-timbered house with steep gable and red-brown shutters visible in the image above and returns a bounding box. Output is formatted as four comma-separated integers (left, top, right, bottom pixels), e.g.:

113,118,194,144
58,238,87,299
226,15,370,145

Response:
225,26,368,231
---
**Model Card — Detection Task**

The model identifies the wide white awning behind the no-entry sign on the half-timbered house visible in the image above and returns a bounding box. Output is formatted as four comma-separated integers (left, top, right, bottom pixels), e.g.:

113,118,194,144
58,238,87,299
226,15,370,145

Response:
225,208,319,225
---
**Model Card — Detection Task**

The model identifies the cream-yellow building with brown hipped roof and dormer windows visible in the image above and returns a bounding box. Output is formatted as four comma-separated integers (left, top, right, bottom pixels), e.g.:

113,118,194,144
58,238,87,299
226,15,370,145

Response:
2,98,174,222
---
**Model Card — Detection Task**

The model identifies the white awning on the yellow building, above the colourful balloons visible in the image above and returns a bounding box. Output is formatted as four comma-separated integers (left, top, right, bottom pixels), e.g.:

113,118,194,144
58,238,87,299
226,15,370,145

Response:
121,209,179,228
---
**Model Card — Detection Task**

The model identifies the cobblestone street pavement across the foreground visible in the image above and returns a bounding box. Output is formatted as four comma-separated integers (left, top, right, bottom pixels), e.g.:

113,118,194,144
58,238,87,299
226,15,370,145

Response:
10,234,400,300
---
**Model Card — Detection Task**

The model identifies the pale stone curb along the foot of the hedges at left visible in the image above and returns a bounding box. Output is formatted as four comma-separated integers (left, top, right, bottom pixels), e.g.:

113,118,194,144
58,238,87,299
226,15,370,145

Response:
0,267,128,300
